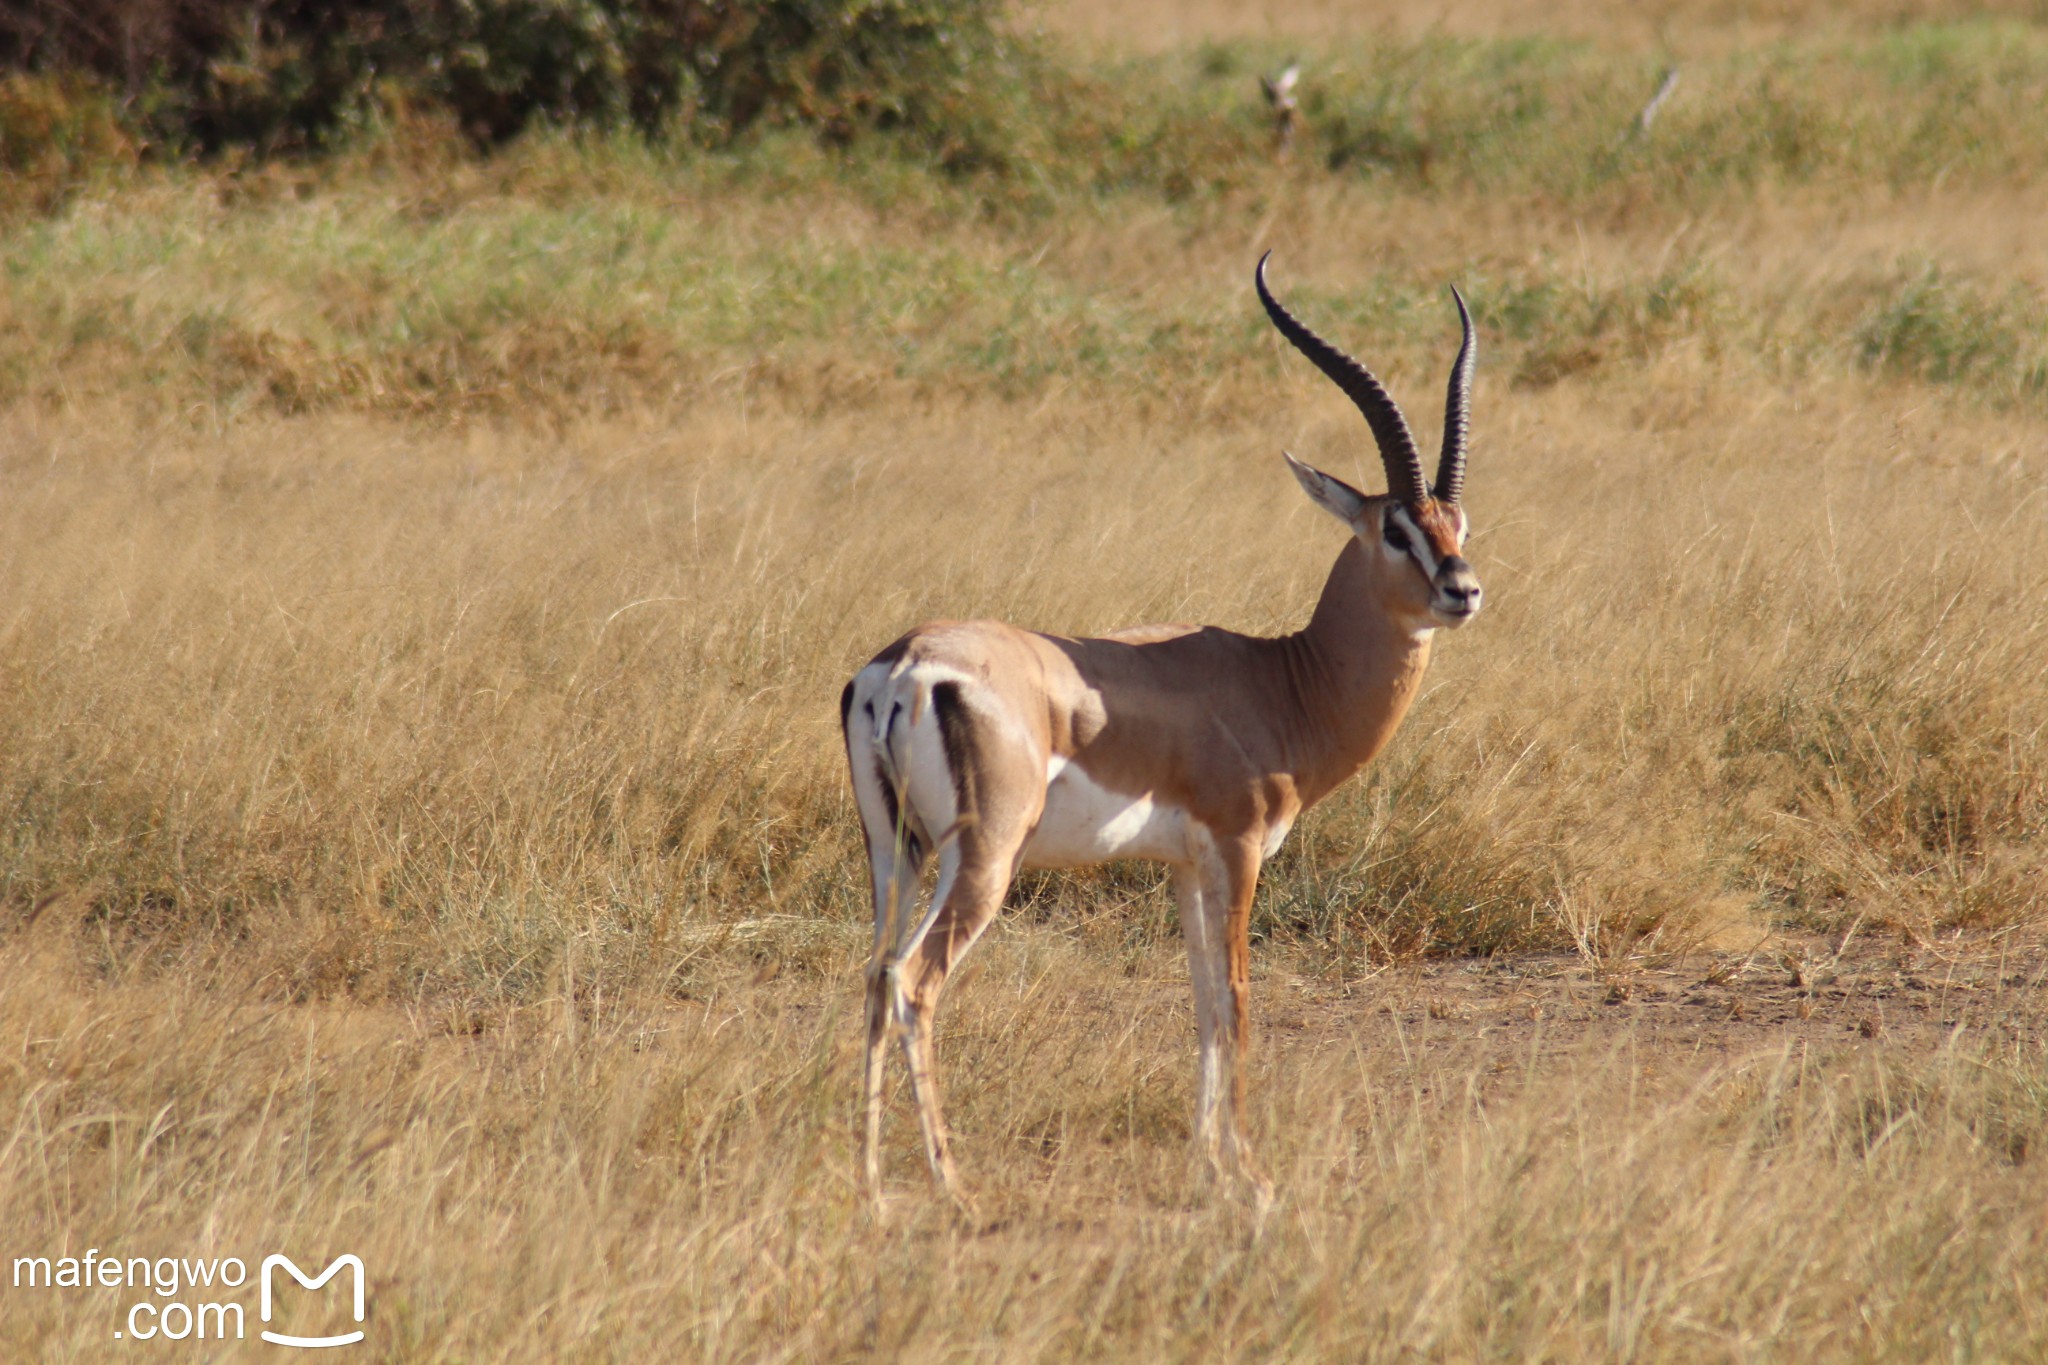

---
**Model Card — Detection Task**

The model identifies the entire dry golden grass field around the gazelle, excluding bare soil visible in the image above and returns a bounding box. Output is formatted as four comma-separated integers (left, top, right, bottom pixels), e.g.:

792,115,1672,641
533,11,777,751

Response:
0,343,2048,1359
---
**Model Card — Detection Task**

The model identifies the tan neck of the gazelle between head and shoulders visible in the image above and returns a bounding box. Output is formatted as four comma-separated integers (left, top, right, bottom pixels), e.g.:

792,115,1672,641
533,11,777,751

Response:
1286,536,1436,806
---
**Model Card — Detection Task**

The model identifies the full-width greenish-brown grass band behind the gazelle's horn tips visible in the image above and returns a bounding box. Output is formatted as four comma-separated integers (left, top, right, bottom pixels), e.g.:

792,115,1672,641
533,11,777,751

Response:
12,173,2048,415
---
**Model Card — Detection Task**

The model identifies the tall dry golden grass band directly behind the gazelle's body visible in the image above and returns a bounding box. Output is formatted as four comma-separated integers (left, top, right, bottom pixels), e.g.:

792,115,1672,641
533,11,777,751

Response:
0,294,2044,970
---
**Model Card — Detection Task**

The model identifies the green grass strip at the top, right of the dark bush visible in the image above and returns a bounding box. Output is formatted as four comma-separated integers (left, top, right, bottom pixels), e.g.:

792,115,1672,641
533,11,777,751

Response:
1014,20,2048,209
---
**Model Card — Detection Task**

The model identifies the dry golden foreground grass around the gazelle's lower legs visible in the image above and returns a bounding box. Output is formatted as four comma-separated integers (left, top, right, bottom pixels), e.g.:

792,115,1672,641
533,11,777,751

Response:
0,908,2048,1361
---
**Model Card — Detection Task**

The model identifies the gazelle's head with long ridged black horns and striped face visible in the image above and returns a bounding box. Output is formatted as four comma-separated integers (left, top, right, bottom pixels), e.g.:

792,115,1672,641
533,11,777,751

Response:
1253,252,1481,628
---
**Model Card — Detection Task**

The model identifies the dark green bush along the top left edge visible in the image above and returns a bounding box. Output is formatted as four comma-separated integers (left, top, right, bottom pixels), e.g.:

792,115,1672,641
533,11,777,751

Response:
0,0,1006,153
